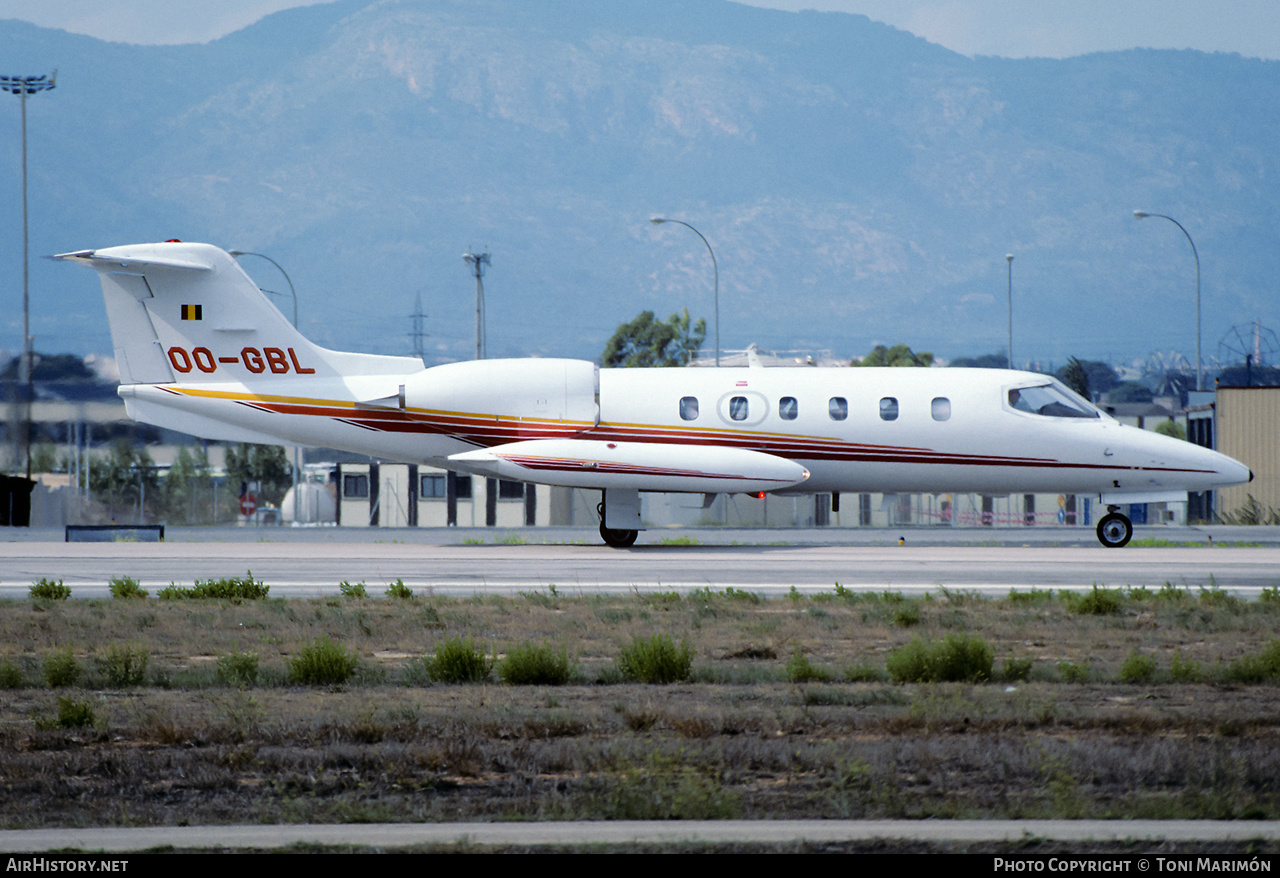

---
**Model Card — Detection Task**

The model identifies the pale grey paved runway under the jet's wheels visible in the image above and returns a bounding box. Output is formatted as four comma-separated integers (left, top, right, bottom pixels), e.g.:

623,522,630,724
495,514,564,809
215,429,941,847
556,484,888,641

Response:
0,529,1280,598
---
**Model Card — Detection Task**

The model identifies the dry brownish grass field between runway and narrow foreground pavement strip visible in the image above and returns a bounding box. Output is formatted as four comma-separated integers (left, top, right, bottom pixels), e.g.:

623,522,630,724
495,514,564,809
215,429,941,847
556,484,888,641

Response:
0,583,1280,827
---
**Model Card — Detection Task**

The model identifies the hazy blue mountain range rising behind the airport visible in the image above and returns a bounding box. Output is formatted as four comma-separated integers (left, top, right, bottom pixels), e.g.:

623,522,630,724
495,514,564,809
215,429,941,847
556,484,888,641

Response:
0,0,1280,363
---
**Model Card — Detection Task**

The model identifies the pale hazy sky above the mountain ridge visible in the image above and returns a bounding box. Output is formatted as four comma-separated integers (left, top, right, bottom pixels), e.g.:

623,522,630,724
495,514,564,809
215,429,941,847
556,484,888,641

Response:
0,0,1280,59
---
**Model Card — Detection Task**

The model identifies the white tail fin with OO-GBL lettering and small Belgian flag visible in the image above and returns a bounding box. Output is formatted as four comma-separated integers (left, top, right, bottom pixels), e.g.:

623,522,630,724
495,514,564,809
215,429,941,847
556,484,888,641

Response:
55,242,422,384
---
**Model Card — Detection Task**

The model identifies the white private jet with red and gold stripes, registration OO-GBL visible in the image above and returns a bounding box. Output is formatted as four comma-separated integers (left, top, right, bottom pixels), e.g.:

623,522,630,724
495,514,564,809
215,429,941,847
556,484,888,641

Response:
55,242,1252,547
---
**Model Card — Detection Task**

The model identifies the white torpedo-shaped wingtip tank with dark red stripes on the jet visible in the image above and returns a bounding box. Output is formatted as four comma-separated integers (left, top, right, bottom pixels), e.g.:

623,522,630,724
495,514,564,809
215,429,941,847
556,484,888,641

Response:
449,439,809,494
